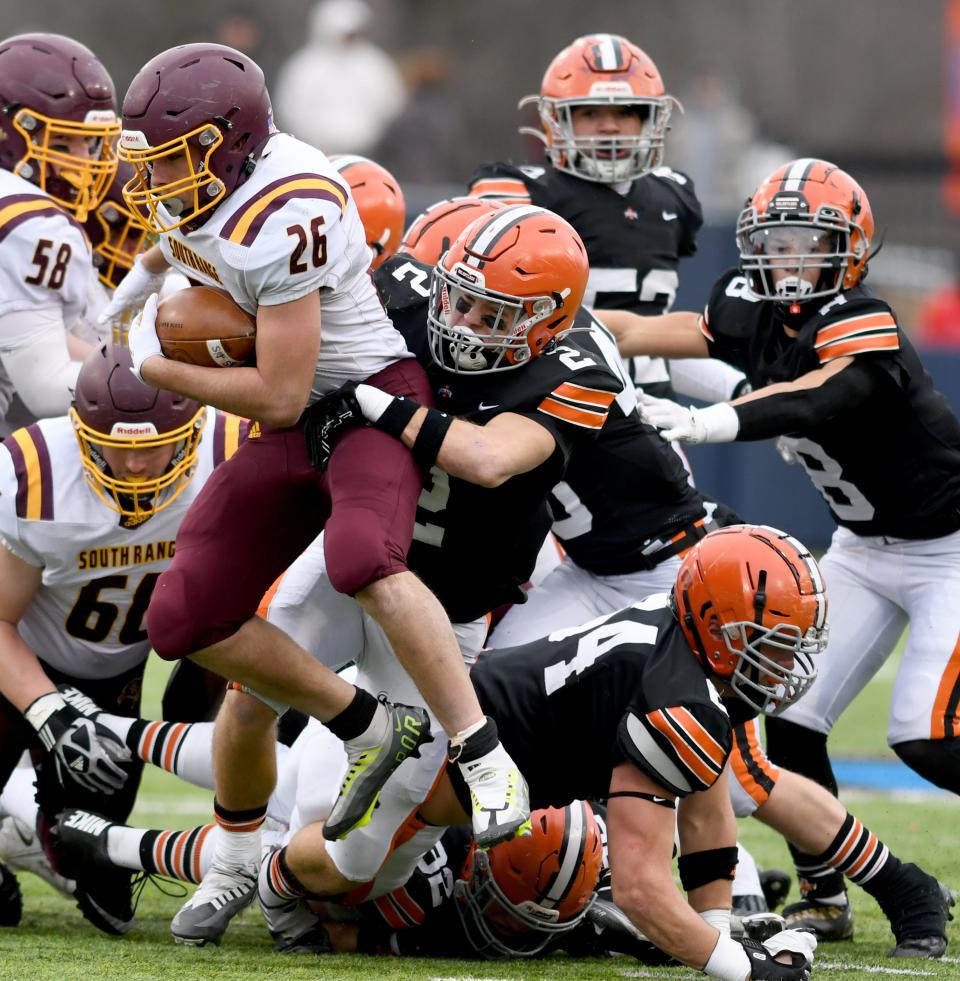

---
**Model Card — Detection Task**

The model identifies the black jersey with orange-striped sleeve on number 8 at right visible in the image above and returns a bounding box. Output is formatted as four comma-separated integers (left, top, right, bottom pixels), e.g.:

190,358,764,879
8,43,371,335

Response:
700,270,960,539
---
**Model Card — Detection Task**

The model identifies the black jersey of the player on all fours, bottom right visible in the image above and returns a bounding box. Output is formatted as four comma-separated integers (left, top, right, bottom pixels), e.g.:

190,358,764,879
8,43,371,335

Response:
470,594,736,808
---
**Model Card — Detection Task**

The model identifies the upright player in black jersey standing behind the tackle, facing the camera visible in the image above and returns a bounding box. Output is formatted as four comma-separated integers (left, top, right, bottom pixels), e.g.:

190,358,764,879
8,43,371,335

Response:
469,34,743,400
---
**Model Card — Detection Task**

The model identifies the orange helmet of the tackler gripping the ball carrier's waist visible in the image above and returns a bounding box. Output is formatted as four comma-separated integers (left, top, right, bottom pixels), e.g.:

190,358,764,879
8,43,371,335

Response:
427,205,589,374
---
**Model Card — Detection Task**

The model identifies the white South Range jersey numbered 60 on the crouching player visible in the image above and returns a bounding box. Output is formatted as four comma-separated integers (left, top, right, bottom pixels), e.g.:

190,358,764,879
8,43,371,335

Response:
0,409,246,678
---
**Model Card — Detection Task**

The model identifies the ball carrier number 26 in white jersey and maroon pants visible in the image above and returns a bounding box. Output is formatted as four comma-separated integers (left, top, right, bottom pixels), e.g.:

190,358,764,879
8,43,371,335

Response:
104,44,529,942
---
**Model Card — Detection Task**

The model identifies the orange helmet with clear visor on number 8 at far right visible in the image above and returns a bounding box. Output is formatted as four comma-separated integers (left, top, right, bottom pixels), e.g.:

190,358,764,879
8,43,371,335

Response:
737,158,874,304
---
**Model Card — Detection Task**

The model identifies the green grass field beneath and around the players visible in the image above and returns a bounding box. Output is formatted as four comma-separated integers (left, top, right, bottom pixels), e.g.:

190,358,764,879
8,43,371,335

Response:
0,640,960,981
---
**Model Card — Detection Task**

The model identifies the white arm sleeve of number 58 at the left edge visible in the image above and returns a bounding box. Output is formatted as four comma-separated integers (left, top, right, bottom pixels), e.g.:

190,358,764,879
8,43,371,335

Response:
0,307,80,419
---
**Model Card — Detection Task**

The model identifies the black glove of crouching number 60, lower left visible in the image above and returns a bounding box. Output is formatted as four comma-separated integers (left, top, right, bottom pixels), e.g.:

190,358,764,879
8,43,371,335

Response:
31,704,131,794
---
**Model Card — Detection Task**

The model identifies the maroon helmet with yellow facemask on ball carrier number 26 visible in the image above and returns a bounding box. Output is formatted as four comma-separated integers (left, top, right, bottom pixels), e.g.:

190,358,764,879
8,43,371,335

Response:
119,43,274,233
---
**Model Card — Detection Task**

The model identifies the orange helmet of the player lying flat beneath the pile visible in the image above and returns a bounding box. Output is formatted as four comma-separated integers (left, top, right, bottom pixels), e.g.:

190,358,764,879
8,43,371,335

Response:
453,800,603,958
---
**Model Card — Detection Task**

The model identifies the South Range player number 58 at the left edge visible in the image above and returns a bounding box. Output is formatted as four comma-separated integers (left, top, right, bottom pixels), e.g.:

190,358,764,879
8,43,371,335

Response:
0,34,120,432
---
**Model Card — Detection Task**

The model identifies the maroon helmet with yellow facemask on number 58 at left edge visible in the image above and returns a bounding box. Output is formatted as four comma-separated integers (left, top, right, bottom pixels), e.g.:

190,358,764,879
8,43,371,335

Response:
0,34,120,221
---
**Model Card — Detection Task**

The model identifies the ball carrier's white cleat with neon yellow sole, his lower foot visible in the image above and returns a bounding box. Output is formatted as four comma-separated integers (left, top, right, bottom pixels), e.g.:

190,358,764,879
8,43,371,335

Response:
458,743,530,848
